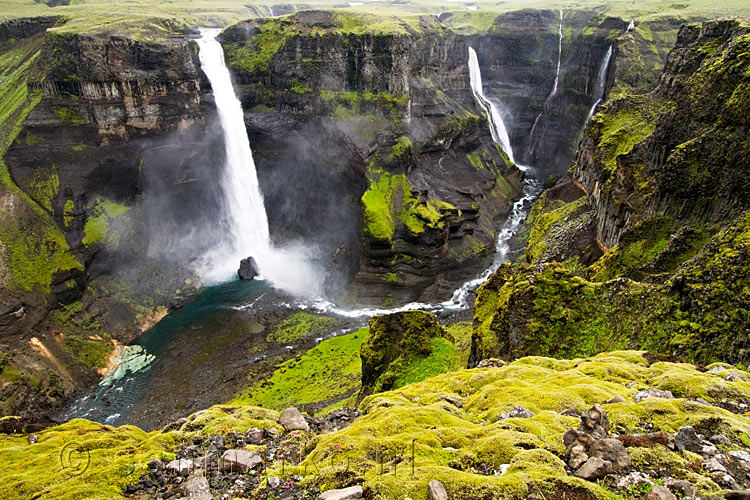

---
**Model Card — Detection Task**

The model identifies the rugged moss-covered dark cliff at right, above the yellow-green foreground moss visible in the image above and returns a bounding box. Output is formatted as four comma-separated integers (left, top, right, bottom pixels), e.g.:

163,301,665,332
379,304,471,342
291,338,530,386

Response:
471,21,750,363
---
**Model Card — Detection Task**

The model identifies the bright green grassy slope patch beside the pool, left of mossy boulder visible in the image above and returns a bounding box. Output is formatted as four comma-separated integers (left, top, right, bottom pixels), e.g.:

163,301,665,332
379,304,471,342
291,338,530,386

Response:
233,328,367,410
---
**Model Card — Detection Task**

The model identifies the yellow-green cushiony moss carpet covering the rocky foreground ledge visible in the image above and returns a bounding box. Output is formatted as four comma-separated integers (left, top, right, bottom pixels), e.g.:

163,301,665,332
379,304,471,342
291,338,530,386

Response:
0,351,750,500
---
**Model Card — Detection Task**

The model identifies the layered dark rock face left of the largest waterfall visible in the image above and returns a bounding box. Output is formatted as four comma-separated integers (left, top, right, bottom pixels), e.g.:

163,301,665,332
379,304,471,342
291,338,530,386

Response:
0,23,223,412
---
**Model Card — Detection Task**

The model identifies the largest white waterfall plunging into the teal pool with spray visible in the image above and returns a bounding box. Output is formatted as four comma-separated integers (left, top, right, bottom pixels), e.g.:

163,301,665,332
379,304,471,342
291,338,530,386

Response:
198,30,322,295
